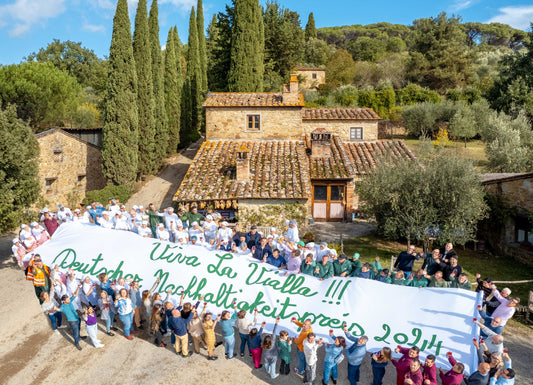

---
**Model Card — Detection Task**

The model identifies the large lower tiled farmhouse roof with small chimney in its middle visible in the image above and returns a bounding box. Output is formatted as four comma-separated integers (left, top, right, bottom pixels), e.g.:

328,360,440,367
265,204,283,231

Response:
174,140,311,201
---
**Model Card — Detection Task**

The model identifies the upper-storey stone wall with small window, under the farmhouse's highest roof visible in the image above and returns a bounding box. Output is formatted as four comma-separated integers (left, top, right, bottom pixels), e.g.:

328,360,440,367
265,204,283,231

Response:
205,107,305,140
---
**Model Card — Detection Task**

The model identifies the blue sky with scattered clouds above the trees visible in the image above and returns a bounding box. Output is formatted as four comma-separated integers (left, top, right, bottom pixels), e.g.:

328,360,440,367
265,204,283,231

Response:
0,0,533,65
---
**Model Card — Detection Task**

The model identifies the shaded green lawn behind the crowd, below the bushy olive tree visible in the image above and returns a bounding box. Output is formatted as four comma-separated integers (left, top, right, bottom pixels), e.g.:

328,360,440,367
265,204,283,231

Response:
344,231,533,318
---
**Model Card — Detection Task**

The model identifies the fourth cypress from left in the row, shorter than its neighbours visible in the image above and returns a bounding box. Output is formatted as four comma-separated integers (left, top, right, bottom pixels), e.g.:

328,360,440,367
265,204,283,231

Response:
165,28,183,154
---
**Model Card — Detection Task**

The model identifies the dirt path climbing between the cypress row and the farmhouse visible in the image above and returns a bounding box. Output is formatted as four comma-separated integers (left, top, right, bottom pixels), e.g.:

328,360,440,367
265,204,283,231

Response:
126,139,203,210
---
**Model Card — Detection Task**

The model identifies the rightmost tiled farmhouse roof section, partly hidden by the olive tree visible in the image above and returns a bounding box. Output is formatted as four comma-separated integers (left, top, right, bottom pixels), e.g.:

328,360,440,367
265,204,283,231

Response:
343,140,416,176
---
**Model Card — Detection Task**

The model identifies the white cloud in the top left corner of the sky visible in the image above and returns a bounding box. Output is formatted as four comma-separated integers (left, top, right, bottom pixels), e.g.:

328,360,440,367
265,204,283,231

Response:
0,0,66,37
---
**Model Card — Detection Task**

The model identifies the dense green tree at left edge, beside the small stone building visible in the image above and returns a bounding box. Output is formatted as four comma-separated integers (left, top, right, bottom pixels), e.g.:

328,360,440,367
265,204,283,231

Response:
0,106,39,233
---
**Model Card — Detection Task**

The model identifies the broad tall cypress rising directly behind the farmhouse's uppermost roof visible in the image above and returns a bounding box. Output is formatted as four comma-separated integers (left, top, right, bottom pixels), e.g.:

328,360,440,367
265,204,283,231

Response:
228,0,265,92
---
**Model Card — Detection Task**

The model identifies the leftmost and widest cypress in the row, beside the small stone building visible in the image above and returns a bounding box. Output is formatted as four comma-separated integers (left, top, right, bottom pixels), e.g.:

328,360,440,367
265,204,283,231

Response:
102,0,138,187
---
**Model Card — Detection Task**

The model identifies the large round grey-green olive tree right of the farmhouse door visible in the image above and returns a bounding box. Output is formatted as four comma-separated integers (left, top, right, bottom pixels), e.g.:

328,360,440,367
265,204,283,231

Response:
358,151,486,244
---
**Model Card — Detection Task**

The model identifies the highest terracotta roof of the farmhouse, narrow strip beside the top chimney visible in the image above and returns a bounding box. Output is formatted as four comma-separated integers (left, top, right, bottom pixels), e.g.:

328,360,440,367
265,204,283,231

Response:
203,92,305,107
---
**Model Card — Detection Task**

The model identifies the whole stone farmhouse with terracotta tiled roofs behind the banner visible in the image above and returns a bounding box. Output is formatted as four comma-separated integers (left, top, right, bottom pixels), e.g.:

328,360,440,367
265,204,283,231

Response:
174,75,414,221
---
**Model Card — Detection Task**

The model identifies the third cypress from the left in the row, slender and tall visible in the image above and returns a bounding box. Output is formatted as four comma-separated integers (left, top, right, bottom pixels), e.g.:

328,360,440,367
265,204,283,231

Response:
148,0,169,160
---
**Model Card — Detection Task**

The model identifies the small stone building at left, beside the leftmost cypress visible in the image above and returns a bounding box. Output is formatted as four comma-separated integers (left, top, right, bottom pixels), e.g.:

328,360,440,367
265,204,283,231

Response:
35,128,106,209
